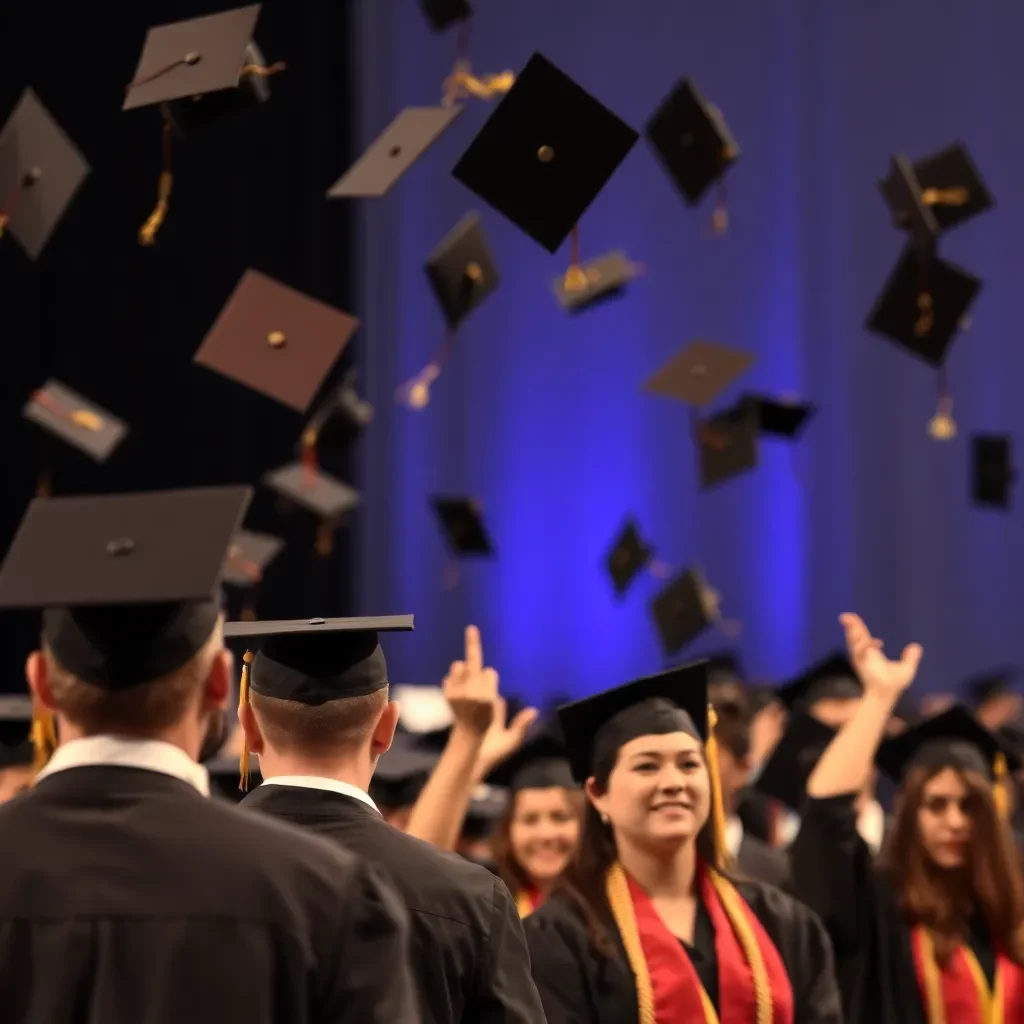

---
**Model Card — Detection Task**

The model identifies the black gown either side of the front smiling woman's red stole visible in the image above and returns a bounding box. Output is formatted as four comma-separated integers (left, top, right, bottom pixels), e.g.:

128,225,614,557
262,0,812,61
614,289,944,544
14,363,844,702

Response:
524,882,843,1024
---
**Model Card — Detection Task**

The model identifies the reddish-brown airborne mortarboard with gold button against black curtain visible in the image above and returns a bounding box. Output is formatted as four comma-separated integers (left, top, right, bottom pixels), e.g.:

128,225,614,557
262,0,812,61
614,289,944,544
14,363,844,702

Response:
195,270,359,413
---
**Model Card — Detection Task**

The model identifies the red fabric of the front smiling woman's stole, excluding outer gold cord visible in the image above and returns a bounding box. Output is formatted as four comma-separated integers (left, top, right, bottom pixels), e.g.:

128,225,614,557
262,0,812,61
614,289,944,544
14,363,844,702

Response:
627,868,794,1024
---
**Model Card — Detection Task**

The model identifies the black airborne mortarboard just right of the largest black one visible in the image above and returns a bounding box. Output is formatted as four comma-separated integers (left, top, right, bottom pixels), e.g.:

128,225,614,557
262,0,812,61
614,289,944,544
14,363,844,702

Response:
644,79,739,206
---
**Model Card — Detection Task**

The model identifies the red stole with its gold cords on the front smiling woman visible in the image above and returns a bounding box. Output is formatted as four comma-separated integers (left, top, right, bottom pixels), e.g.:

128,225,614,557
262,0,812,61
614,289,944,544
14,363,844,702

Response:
606,863,794,1024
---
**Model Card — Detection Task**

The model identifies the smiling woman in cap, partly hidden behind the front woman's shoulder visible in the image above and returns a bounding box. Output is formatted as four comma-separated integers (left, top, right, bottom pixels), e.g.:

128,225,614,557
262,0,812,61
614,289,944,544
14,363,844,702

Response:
490,732,584,918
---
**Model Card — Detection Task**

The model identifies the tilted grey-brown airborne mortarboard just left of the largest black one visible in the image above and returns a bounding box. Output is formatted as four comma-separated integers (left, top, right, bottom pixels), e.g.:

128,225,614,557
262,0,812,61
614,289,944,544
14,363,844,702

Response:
327,105,463,199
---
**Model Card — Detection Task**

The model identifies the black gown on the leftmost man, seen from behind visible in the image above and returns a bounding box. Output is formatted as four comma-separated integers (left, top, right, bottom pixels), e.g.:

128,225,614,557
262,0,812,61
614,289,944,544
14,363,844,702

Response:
0,766,420,1024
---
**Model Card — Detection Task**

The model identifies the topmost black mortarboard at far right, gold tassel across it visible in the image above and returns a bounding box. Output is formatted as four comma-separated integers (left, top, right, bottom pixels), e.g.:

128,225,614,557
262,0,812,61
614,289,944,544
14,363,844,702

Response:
879,142,994,232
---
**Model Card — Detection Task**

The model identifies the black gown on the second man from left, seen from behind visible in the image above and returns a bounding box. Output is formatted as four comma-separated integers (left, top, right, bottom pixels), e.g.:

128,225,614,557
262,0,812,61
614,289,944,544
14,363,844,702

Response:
241,784,544,1024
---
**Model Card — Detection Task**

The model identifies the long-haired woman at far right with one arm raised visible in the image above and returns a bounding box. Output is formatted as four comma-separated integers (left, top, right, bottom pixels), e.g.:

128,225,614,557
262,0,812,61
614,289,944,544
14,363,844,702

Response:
792,615,1024,1024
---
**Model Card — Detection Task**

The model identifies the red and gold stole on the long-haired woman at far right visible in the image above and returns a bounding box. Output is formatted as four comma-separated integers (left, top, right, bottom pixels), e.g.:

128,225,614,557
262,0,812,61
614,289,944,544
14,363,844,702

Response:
910,925,1024,1024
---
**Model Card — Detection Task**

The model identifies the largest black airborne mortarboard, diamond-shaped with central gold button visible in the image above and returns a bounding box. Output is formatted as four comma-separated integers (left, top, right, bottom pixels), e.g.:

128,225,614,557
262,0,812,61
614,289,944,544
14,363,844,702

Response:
452,53,639,253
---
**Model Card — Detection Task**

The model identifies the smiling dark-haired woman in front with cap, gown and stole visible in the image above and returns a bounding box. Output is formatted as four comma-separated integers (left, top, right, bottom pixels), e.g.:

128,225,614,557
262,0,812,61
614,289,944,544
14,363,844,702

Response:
524,663,842,1024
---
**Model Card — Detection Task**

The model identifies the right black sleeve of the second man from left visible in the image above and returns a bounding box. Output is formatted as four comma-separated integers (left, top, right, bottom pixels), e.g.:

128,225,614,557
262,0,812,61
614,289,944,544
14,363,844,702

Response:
466,879,544,1024
